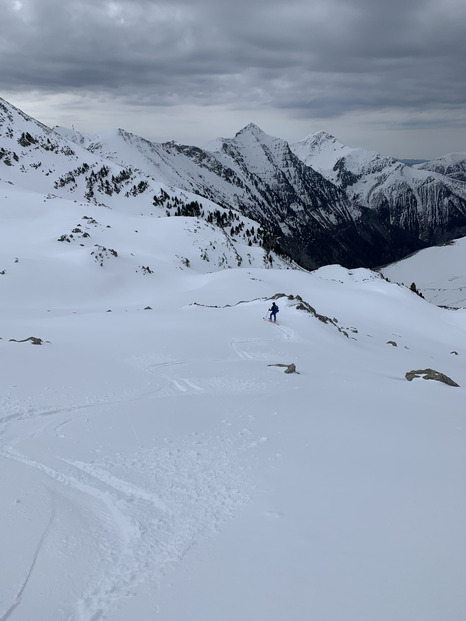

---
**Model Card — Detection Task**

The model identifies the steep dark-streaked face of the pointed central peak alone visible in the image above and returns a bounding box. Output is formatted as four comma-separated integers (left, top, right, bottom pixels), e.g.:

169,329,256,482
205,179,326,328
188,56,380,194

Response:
196,124,366,268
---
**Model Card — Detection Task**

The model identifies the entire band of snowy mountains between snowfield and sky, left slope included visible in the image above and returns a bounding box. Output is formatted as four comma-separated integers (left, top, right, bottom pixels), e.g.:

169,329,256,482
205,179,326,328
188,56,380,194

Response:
0,99,466,269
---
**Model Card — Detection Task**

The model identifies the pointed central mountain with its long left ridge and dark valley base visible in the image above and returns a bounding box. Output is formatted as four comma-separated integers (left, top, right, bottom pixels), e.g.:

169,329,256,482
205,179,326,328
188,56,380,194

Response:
57,124,434,269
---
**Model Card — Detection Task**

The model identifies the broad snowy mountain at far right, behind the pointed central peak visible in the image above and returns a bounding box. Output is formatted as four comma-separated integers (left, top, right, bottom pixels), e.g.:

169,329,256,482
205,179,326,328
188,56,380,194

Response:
291,132,466,245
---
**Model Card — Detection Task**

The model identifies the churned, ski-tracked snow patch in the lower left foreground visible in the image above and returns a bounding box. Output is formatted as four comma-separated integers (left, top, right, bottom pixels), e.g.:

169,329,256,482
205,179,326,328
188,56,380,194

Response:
0,426,255,621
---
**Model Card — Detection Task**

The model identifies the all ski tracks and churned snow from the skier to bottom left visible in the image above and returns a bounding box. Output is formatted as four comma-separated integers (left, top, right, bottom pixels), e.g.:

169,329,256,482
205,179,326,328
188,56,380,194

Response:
0,290,324,621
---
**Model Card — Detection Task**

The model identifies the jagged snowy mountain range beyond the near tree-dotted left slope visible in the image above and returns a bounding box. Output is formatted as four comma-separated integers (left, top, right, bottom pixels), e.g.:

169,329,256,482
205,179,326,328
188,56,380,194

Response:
57,124,466,268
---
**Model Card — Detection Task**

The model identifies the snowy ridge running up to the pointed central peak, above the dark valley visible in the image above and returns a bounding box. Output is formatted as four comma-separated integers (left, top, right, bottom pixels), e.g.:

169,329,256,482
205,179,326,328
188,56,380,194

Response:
55,118,357,267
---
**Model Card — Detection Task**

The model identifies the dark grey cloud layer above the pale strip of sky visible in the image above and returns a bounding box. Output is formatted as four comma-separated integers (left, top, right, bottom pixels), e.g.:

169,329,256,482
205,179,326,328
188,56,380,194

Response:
0,0,466,143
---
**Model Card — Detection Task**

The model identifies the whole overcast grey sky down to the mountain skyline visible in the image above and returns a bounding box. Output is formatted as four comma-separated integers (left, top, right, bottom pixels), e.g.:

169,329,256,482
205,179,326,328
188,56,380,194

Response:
0,0,466,159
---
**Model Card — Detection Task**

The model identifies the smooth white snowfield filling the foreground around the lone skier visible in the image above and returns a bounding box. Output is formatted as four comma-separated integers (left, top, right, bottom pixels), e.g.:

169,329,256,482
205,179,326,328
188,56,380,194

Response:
0,177,466,621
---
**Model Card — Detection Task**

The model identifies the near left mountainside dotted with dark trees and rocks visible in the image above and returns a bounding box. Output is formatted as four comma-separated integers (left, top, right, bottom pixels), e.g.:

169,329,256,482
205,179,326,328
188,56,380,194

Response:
0,99,290,270
